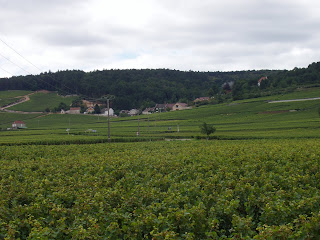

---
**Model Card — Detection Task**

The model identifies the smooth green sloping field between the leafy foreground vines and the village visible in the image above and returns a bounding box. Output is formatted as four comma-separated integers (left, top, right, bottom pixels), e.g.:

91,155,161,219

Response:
0,88,320,144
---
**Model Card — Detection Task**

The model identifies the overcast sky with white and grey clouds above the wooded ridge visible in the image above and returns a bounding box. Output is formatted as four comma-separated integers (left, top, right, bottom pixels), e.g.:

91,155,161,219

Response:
0,0,320,77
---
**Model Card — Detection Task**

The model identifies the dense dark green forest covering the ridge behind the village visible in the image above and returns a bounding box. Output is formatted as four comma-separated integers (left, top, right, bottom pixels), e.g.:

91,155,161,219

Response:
0,63,320,109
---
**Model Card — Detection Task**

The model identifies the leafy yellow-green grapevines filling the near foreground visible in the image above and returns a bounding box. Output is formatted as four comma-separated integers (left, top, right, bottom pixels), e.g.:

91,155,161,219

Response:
0,139,320,239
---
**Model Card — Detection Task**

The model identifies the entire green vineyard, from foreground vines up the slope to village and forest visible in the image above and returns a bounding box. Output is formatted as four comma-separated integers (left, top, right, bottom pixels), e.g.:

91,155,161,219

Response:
0,88,320,240
